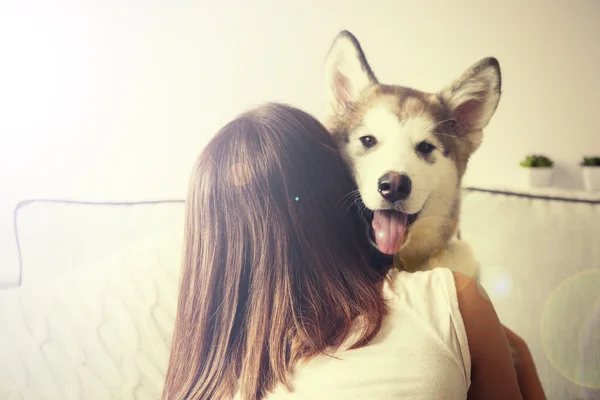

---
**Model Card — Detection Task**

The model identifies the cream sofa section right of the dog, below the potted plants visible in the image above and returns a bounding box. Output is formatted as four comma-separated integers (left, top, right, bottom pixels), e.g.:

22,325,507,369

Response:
461,188,600,400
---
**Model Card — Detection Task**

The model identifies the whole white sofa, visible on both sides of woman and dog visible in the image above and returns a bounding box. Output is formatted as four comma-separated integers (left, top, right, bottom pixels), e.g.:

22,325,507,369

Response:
0,190,600,400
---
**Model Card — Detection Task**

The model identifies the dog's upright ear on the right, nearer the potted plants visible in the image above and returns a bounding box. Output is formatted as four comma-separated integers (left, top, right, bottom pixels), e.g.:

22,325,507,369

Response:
440,57,502,134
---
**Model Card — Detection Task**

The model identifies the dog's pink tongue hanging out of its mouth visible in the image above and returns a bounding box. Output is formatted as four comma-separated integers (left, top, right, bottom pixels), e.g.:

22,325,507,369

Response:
371,210,407,255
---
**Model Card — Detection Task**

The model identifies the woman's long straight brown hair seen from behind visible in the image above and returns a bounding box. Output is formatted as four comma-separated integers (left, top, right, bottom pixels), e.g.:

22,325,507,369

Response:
163,103,387,400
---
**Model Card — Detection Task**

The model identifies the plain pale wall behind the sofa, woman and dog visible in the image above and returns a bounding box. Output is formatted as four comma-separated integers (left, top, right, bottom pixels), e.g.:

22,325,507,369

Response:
0,0,600,276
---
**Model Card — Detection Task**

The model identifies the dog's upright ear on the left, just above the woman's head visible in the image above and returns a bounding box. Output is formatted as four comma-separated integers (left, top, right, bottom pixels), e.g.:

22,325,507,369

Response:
325,30,377,121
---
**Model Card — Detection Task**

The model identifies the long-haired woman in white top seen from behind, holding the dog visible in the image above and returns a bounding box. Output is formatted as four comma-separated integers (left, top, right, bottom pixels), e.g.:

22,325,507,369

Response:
163,104,540,400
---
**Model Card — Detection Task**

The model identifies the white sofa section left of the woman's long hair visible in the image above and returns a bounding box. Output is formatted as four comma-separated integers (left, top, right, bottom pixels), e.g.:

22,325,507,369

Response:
0,202,183,400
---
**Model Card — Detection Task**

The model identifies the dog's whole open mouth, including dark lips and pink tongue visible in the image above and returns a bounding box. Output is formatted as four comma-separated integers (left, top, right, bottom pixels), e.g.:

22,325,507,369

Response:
366,210,419,255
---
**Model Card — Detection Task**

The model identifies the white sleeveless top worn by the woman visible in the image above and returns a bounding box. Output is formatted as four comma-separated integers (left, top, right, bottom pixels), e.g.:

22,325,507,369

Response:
236,268,471,400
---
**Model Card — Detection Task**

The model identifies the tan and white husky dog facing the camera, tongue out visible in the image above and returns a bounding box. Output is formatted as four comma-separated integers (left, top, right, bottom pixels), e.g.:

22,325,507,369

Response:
323,31,501,276
